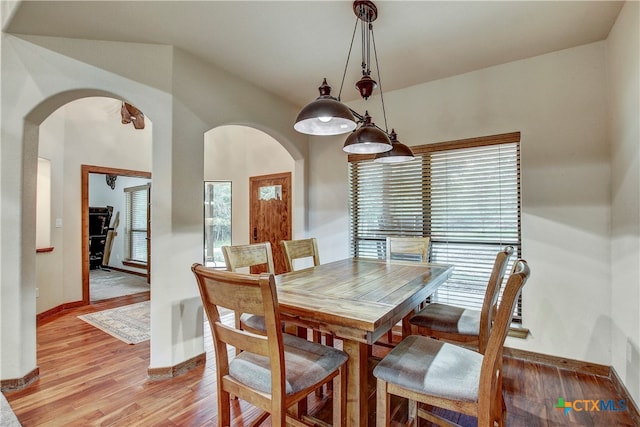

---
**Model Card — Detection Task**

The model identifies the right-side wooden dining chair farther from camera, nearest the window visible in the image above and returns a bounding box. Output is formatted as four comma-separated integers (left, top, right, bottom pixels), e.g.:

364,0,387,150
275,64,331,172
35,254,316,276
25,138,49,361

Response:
409,246,514,353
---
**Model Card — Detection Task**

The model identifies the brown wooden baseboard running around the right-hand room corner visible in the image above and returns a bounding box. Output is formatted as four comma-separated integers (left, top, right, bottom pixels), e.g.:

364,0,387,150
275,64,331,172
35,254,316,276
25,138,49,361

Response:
503,347,640,426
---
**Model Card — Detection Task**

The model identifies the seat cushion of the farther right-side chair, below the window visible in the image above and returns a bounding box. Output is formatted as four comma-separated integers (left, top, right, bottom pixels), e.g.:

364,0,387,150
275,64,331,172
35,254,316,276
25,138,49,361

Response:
410,303,480,336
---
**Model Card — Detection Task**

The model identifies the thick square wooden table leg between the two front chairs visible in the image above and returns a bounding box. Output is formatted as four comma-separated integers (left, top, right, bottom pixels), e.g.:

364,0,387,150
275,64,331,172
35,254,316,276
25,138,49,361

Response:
342,339,369,427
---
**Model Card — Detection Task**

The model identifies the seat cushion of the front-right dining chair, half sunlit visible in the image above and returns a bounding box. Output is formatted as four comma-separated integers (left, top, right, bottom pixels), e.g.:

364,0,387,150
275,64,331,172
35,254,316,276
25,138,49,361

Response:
373,335,483,402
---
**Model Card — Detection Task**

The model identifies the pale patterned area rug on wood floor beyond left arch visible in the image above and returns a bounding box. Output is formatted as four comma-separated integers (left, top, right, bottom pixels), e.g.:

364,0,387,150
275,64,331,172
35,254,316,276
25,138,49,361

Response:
78,301,151,344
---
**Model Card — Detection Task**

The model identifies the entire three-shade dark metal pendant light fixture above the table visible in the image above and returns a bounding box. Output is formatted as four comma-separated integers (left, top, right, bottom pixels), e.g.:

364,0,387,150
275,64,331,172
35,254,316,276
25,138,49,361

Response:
294,0,413,163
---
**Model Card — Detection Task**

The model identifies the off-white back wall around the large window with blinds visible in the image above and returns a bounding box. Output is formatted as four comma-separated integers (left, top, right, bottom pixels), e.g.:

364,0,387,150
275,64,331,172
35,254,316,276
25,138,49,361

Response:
309,42,608,365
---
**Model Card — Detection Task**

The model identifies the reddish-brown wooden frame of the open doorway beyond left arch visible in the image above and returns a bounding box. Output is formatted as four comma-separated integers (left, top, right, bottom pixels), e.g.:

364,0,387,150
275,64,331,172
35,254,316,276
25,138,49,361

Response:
80,165,151,305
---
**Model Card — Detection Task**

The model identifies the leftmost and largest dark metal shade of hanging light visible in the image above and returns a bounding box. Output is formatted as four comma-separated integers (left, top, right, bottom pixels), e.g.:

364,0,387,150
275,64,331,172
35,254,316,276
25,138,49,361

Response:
293,79,356,135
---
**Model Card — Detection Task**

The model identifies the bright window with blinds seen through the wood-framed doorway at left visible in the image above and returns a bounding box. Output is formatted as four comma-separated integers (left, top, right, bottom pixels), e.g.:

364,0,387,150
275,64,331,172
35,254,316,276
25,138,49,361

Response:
124,184,151,264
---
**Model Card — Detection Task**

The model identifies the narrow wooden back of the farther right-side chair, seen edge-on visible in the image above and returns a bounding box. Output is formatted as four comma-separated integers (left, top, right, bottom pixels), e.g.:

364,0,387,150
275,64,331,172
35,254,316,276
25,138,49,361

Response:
478,246,516,354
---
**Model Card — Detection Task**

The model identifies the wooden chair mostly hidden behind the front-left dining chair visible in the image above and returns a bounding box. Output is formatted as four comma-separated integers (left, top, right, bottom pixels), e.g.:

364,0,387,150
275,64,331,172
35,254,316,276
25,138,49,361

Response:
221,242,275,333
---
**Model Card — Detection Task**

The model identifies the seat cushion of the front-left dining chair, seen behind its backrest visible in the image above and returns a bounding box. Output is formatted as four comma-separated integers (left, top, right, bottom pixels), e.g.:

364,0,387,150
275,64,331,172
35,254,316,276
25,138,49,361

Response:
229,334,348,394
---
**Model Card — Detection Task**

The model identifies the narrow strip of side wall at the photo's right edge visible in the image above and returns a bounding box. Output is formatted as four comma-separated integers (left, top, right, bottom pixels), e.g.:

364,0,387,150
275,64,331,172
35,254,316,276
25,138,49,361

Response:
607,1,640,402
